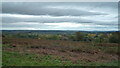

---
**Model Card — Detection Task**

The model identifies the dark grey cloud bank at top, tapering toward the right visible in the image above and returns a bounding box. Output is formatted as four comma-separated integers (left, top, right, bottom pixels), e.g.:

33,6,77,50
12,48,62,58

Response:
2,3,107,16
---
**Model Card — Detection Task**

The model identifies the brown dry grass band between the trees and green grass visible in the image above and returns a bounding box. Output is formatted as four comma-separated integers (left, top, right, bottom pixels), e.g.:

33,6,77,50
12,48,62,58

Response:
3,38,118,63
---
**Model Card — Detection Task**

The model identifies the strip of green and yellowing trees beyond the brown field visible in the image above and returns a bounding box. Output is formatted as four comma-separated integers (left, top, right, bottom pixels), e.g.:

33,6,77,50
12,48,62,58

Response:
2,32,120,43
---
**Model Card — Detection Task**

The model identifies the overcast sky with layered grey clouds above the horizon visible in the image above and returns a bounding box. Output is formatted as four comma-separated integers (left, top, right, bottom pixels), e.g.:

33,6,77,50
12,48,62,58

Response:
0,2,118,31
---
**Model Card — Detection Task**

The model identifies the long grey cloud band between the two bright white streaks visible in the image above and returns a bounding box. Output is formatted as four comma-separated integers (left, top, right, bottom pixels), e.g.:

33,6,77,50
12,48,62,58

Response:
2,16,118,25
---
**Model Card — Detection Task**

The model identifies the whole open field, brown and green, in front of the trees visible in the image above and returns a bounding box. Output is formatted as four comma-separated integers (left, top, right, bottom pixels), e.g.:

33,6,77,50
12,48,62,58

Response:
2,38,118,66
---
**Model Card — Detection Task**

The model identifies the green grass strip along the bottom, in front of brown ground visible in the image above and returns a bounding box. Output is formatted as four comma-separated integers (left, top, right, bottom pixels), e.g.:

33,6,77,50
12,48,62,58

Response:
3,52,118,66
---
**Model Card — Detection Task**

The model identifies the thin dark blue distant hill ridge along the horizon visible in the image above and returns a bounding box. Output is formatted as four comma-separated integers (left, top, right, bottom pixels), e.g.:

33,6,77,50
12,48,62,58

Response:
2,30,118,34
